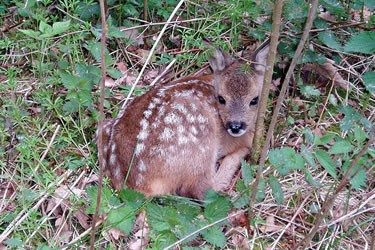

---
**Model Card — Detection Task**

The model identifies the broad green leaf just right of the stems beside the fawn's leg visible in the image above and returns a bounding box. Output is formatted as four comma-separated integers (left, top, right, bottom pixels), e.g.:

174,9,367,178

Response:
269,147,305,176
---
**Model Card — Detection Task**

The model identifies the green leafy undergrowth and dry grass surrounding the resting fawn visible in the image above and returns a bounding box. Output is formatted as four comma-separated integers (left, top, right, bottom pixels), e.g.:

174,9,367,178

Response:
0,0,375,249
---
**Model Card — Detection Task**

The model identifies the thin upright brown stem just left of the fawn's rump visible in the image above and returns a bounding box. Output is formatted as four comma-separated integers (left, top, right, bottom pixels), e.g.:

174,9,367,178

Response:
90,0,107,247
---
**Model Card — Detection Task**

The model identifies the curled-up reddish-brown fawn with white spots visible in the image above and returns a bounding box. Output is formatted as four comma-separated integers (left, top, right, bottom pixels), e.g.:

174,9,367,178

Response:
102,43,268,199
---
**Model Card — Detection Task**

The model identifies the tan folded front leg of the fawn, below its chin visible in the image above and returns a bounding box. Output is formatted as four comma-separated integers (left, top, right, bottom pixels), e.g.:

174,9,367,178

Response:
214,148,249,191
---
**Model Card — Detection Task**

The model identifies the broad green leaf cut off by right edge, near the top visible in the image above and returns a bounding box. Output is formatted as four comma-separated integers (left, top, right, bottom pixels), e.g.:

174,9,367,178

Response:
345,31,375,55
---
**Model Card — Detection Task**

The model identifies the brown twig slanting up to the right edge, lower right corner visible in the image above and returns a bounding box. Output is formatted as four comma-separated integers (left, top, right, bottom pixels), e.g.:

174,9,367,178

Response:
295,137,375,249
